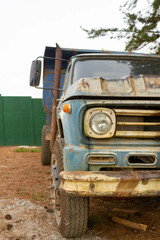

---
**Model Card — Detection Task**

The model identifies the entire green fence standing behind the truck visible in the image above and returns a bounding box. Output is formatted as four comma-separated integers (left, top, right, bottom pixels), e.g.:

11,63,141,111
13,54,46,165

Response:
0,96,46,146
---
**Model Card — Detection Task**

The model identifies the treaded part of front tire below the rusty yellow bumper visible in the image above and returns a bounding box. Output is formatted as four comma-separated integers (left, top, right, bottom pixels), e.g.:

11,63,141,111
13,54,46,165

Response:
55,194,88,238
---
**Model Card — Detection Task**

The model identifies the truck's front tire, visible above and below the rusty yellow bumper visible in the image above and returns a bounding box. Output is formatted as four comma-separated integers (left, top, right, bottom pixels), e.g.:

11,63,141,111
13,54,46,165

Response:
51,139,89,238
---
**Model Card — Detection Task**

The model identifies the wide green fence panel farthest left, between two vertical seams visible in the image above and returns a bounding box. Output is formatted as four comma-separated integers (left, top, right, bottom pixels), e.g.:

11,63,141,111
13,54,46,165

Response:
3,97,34,146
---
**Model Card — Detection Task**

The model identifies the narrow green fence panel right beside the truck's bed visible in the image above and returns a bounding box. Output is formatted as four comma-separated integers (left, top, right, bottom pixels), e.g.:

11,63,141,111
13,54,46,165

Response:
32,99,46,146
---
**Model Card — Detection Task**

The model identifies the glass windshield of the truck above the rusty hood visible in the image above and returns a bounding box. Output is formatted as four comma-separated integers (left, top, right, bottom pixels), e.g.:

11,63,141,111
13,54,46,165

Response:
73,59,160,82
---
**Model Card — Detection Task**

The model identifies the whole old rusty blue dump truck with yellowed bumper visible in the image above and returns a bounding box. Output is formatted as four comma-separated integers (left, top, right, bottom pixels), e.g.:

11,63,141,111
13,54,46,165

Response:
30,45,160,237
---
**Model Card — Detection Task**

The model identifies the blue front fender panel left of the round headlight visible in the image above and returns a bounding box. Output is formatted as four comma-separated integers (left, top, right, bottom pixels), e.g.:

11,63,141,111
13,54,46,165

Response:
57,99,89,171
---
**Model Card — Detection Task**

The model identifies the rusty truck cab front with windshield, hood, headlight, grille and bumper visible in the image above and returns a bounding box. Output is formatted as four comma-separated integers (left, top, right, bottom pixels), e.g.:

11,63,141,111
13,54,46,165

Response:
58,54,160,197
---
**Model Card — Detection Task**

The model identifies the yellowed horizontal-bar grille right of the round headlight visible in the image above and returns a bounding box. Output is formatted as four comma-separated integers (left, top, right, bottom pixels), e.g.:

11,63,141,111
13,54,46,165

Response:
114,109,160,138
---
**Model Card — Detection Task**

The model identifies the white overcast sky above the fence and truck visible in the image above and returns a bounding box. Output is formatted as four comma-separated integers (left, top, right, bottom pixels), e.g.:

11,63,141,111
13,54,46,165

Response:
0,0,149,98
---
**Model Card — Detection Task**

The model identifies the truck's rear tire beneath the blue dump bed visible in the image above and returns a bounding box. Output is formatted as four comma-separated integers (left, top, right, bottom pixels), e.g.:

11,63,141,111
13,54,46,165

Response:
41,125,51,165
